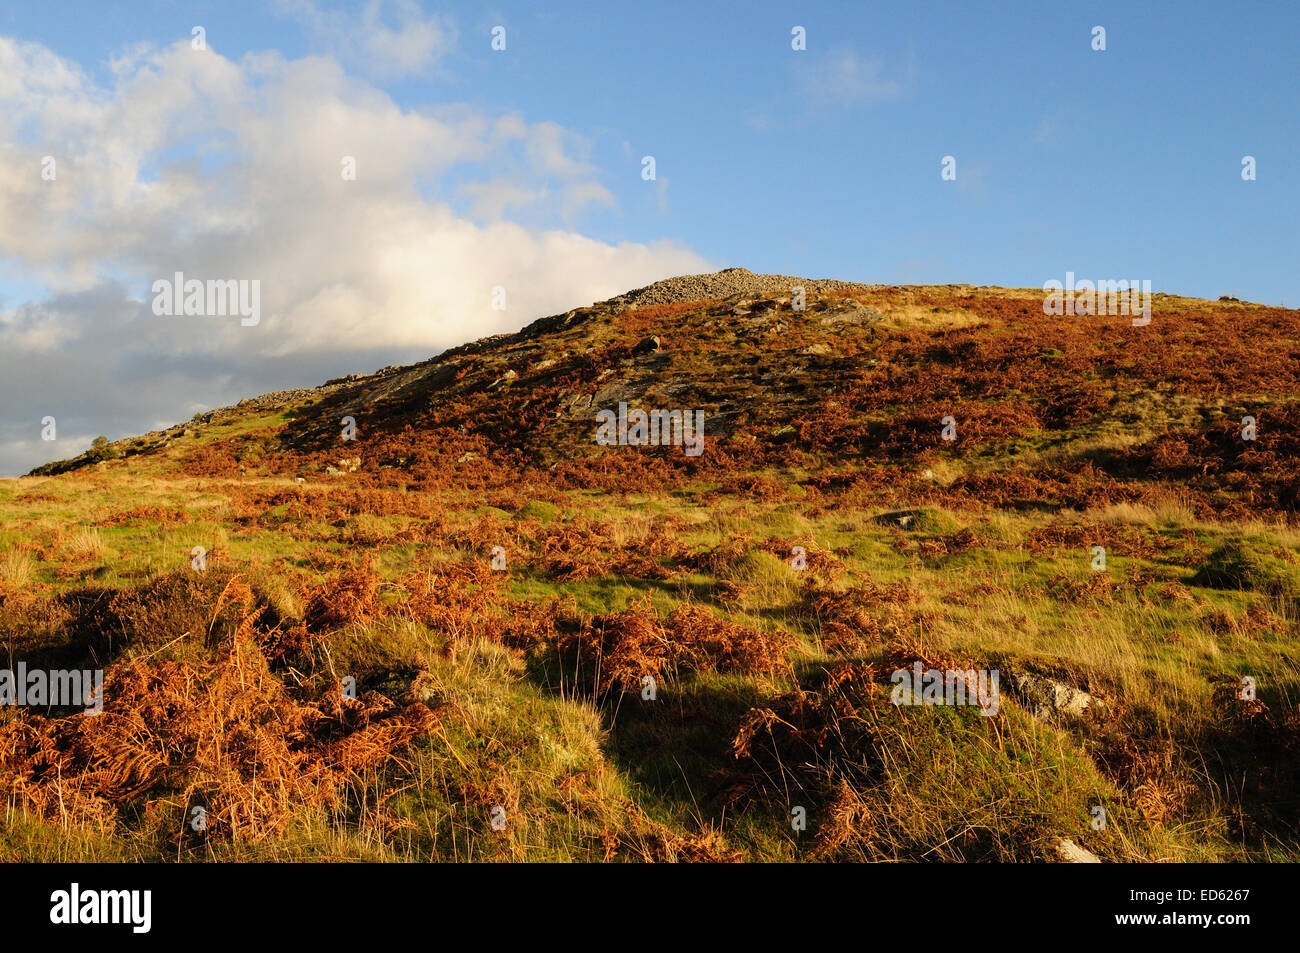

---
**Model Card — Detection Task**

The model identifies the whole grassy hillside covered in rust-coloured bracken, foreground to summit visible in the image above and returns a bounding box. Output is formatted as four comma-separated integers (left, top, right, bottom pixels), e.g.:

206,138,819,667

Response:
0,276,1300,861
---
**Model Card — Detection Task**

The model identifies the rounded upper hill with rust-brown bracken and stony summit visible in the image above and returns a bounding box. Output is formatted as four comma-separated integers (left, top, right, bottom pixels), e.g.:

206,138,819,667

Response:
34,269,1300,516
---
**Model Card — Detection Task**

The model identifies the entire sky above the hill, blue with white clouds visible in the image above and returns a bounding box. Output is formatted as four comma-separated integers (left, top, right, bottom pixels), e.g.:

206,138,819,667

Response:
0,0,1300,473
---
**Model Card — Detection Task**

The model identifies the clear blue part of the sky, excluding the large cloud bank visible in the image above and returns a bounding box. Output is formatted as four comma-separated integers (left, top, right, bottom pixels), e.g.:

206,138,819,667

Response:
3,0,1300,306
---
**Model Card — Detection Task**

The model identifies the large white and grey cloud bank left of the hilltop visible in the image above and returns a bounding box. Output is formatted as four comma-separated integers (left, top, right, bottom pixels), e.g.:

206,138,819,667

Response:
0,38,709,473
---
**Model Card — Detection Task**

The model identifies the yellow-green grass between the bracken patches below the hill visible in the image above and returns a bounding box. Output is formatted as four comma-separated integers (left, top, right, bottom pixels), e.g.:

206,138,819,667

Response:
0,457,1300,861
